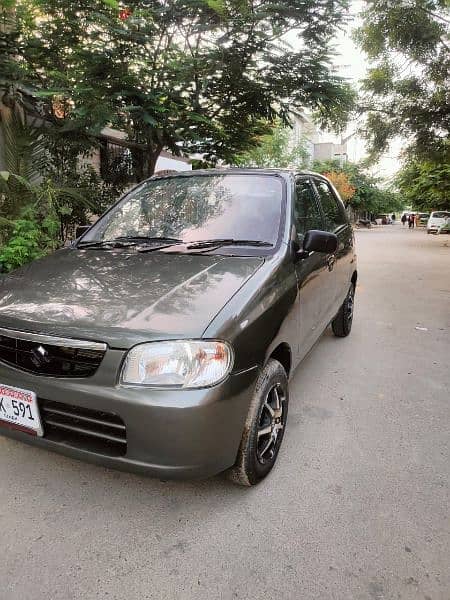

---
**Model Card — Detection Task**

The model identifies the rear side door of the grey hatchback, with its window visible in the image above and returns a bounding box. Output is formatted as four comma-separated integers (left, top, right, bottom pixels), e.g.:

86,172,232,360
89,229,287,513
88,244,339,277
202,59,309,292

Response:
313,177,354,320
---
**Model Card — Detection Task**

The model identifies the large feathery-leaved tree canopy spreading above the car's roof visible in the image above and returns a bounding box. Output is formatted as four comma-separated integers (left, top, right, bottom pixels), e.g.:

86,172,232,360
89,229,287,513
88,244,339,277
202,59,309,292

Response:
2,0,353,177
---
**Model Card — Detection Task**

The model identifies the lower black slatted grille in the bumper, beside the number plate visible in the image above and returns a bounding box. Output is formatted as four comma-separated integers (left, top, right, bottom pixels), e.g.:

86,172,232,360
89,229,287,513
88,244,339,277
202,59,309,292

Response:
38,398,127,456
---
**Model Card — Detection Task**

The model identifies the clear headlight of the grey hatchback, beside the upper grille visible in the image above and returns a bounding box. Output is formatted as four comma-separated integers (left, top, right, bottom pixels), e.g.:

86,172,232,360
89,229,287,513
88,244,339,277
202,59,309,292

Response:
121,340,233,389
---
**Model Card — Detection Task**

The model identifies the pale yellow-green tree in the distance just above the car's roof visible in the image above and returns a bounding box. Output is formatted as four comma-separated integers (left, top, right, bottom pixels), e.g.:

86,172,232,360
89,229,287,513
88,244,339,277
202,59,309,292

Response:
233,122,309,169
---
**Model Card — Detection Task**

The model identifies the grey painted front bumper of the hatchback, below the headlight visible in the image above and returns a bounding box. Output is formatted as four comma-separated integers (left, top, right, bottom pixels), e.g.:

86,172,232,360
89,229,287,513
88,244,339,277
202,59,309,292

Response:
0,350,259,479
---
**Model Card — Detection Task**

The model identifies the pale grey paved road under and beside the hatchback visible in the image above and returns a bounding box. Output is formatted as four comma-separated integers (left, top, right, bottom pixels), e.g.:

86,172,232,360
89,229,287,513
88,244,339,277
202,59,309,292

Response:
0,226,450,600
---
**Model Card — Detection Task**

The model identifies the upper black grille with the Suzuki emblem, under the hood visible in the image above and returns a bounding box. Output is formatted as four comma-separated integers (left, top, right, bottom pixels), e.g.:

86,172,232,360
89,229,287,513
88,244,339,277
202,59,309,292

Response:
0,330,105,377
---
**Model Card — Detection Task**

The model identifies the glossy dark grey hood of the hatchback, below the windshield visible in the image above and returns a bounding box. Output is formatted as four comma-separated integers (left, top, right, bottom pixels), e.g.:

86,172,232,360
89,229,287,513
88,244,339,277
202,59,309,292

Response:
0,249,264,348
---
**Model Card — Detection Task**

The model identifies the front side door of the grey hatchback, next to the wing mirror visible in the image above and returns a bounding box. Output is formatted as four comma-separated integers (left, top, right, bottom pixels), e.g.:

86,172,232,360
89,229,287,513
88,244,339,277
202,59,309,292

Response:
294,177,334,360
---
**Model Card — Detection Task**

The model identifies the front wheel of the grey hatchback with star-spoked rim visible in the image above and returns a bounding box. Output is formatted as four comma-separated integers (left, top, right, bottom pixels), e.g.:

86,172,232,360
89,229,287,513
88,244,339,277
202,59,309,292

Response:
228,358,289,486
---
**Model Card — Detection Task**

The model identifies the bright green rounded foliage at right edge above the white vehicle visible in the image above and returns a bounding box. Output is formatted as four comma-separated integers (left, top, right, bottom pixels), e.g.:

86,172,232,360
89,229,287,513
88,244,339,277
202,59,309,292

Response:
396,154,450,211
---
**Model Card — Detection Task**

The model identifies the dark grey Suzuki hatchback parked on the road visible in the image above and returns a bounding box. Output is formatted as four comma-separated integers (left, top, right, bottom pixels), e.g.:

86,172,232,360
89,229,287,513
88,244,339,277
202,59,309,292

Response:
0,169,357,485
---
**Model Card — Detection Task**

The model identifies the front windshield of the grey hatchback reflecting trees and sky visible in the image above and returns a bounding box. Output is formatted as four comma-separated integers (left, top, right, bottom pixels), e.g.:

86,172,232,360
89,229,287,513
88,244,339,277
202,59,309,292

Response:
82,174,283,246
